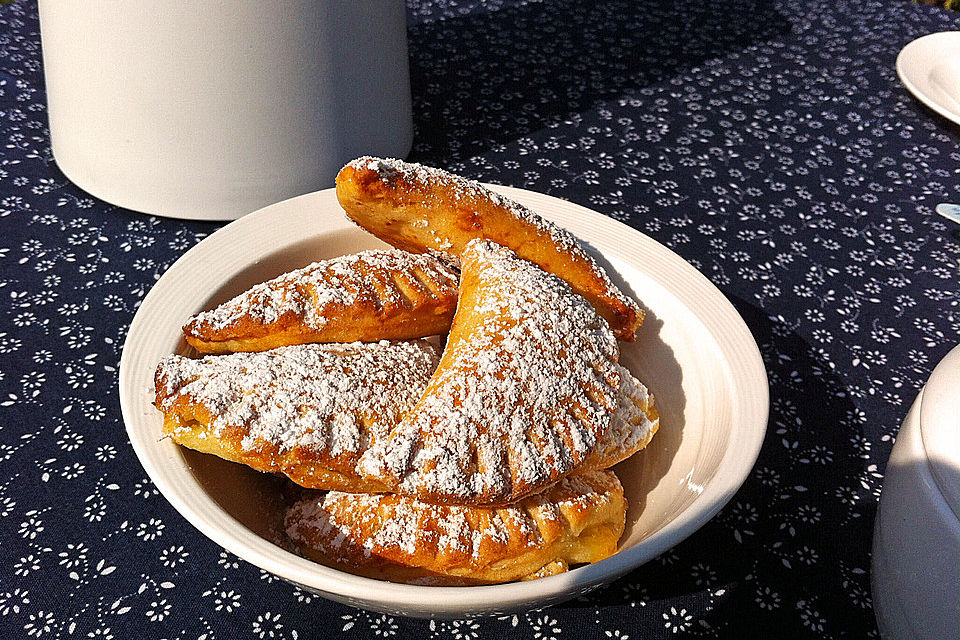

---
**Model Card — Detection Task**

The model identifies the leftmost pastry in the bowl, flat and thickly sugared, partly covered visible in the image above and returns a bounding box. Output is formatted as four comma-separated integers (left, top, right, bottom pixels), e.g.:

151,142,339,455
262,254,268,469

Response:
155,340,440,491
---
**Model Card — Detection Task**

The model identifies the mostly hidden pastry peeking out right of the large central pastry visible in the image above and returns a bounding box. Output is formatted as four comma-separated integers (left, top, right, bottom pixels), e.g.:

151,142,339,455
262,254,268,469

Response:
581,366,660,471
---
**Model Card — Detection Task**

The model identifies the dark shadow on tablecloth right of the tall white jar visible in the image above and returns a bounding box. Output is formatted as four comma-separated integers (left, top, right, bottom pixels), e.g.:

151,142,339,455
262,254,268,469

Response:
410,0,790,153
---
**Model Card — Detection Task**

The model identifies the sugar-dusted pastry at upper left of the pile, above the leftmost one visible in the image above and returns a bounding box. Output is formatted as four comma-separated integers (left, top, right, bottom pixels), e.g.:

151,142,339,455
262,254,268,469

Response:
183,250,457,353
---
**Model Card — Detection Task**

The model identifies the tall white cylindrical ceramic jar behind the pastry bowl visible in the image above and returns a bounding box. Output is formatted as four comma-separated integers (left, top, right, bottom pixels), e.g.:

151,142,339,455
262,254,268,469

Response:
39,0,413,220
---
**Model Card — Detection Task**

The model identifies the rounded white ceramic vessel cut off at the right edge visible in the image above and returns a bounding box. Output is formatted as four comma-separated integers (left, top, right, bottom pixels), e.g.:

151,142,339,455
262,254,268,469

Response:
871,347,960,640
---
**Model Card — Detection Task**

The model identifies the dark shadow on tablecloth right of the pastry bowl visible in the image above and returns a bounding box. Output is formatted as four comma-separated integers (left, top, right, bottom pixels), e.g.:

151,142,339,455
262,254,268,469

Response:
560,296,880,637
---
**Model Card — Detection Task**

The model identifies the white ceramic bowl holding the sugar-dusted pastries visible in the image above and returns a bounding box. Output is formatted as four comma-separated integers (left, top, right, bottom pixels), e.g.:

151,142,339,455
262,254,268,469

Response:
120,187,769,617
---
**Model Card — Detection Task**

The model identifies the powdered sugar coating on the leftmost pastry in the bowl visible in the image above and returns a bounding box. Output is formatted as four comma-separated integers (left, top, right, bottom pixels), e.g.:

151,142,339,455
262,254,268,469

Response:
157,340,439,456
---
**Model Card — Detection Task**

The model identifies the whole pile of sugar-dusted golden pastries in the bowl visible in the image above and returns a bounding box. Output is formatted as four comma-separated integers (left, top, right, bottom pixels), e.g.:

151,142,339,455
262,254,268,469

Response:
156,157,659,585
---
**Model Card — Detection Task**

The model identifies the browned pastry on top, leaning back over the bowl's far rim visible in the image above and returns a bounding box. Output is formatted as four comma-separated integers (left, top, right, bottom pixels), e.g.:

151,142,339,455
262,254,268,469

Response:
336,157,643,340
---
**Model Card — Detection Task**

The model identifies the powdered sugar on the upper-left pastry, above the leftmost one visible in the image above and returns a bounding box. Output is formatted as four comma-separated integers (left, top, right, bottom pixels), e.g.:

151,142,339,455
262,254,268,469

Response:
187,249,458,331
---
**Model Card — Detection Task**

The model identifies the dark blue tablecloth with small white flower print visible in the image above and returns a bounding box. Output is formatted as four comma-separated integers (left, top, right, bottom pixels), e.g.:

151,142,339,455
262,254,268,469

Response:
0,0,960,640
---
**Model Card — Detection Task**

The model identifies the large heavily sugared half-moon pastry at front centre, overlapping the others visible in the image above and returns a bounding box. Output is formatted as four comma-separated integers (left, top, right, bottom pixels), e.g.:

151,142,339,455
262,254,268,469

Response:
359,240,621,505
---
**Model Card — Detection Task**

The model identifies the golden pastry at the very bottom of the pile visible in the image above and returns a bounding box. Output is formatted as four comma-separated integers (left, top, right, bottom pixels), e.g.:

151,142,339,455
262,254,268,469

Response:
284,471,626,585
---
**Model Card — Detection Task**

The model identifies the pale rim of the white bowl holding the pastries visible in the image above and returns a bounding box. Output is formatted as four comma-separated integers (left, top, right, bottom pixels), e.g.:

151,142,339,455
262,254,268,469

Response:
119,184,769,615
